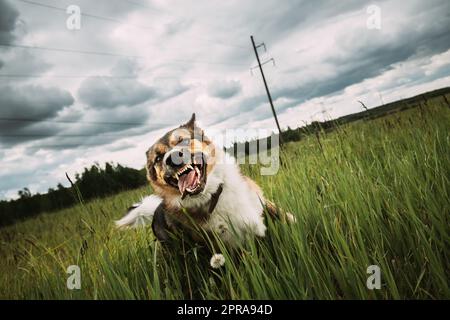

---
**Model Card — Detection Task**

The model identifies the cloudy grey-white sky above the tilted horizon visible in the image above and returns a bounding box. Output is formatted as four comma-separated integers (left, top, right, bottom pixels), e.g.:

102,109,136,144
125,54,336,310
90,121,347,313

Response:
0,0,450,199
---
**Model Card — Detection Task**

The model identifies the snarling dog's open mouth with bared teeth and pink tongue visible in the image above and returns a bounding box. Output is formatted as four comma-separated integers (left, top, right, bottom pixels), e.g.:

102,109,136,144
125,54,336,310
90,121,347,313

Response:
166,156,206,199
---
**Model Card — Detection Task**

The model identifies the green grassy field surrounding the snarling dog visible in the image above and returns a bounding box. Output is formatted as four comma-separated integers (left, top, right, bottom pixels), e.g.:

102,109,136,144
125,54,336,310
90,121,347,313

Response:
0,99,450,299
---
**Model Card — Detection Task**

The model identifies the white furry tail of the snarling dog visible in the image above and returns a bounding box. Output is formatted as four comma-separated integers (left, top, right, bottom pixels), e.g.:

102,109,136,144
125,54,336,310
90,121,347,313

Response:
115,194,162,228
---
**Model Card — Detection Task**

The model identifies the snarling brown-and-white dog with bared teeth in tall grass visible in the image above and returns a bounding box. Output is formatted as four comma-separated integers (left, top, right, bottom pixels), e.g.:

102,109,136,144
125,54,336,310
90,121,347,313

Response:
116,113,295,246
